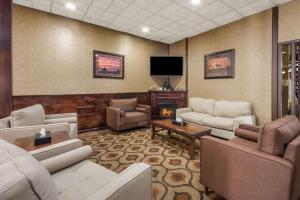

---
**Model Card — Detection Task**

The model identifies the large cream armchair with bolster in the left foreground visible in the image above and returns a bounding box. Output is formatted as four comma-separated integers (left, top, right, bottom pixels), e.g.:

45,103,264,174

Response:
0,139,152,200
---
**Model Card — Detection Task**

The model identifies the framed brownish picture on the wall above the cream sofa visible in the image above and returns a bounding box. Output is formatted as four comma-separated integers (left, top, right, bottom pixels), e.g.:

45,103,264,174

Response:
204,49,235,79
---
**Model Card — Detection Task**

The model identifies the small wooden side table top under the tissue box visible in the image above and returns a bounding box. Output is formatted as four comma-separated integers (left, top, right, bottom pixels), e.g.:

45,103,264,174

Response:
14,131,71,151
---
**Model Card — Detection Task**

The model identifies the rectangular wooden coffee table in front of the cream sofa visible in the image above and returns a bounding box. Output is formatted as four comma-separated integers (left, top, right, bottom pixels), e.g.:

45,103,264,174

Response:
151,119,211,159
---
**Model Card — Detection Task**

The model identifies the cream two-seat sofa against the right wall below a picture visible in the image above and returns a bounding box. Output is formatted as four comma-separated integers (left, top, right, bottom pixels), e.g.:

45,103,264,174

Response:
176,97,255,140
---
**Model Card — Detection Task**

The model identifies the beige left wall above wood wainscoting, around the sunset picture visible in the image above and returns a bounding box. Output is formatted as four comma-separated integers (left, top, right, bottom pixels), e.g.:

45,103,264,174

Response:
13,5,168,95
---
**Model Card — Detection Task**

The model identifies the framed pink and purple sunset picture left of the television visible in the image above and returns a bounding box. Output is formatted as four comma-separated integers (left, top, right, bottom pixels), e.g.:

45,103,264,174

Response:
93,51,124,79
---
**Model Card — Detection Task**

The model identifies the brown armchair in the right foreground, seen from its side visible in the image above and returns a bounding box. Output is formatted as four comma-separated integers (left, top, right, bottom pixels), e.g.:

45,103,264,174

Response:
200,116,300,200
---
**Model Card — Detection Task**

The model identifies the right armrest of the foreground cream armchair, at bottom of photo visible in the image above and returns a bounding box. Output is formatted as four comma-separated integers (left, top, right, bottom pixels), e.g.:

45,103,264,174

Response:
86,163,152,200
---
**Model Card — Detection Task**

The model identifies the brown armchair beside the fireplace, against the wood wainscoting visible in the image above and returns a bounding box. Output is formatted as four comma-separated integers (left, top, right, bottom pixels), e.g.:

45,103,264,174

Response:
106,98,151,131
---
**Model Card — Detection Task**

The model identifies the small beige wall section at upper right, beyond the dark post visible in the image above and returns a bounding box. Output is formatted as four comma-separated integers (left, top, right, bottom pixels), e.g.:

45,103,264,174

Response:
278,0,300,42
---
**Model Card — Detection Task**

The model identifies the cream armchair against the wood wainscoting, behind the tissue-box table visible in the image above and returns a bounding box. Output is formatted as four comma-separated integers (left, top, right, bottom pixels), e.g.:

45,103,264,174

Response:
0,104,78,140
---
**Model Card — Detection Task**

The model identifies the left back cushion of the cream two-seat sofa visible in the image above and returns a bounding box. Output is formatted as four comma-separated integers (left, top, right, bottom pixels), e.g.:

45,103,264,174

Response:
189,97,215,115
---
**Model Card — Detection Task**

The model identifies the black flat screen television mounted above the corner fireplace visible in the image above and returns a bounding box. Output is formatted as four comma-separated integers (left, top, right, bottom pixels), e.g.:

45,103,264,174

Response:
150,57,183,76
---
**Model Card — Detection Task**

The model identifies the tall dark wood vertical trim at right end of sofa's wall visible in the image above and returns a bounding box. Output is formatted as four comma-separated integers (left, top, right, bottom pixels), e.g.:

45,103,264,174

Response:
271,7,279,120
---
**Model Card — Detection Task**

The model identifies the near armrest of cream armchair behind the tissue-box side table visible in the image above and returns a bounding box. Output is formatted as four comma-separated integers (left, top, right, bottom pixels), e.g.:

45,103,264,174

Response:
0,123,69,144
